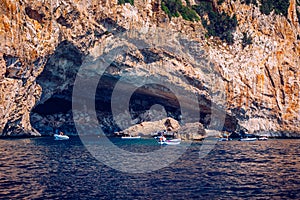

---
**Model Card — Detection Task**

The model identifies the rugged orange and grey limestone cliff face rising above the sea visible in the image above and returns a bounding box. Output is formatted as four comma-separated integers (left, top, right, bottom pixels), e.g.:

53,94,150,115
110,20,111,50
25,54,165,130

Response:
0,0,300,136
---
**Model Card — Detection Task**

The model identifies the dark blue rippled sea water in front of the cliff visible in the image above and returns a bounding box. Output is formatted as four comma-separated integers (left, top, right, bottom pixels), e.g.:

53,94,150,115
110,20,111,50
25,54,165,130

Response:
0,137,300,199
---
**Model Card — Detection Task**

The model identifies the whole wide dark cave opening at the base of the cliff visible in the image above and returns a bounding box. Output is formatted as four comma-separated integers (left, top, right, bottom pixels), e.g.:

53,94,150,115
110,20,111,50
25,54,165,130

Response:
30,41,237,135
